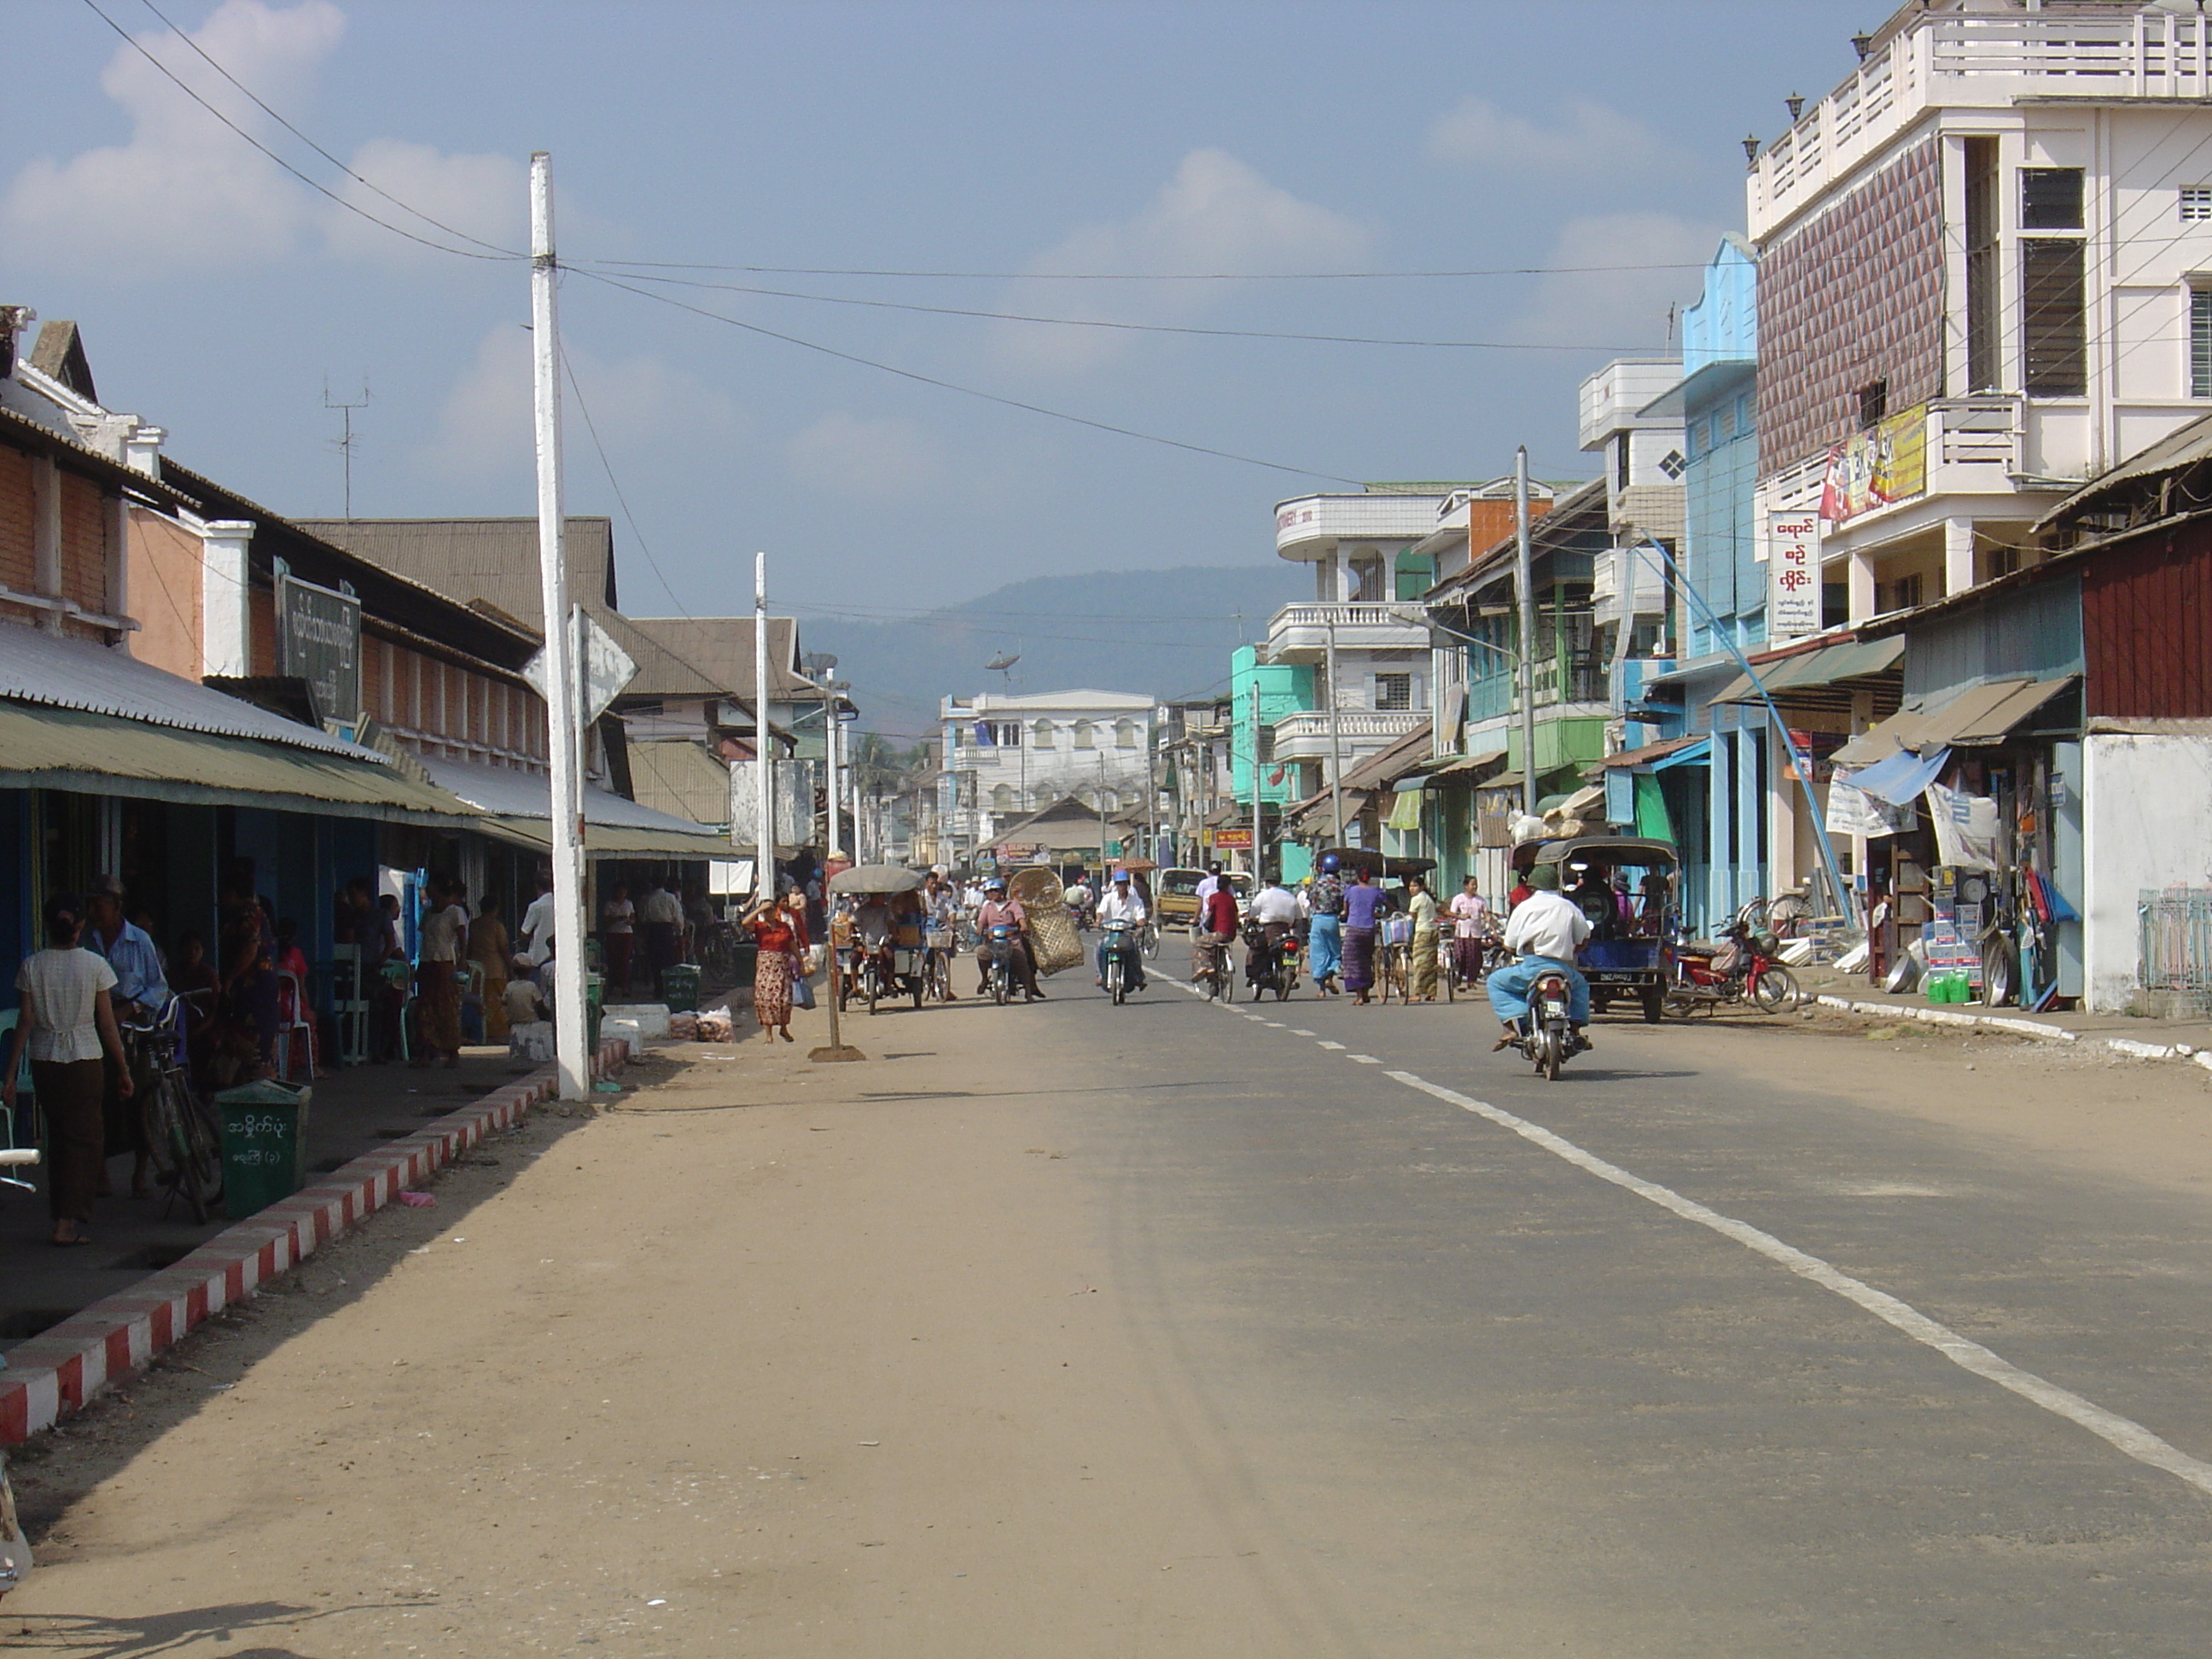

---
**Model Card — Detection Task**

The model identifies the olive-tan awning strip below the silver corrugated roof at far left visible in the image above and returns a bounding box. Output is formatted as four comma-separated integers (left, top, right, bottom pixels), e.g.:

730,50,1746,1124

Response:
0,692,475,825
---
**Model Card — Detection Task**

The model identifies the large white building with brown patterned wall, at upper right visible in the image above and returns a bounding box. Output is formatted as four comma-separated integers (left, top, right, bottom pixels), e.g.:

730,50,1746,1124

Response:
1748,0,2212,621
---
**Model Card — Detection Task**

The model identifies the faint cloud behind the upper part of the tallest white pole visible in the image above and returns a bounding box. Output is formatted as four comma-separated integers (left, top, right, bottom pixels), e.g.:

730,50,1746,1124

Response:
418,323,748,482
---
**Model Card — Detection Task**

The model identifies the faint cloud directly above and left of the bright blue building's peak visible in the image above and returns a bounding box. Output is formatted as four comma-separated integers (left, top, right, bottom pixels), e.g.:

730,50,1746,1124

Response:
1516,212,1721,347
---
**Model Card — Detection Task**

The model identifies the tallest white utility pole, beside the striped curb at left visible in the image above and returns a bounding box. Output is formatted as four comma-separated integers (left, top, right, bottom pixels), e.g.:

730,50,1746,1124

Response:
531,150,591,1099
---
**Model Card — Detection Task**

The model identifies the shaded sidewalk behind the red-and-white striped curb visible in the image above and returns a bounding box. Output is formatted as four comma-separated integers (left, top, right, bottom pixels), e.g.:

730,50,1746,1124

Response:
0,1049,570,1376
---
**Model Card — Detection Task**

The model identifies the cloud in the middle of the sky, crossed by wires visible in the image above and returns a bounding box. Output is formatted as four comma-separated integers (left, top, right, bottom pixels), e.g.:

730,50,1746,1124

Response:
995,150,1374,371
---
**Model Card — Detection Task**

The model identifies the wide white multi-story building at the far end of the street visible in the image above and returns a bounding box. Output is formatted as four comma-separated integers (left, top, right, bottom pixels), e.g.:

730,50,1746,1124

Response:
938,690,1152,849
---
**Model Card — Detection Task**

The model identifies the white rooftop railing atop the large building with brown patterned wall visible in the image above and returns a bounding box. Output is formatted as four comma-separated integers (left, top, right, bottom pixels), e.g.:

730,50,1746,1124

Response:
1749,7,2212,239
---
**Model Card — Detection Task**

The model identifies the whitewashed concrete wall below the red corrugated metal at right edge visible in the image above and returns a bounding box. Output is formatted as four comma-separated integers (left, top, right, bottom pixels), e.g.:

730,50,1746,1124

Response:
2081,732,2212,1013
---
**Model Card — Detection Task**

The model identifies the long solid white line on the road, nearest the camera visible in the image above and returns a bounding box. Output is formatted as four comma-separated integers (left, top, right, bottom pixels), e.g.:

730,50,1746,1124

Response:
1387,1071,2212,1493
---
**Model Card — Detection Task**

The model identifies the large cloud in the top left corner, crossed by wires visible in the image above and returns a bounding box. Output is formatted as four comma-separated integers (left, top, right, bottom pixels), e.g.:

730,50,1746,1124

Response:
0,0,345,265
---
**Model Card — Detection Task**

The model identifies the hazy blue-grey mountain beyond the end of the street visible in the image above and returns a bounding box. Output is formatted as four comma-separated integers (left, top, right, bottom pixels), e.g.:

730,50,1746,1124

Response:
800,564,1312,736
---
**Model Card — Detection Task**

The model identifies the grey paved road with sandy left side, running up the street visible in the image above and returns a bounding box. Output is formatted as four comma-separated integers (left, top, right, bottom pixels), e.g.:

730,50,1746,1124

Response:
7,969,2212,1659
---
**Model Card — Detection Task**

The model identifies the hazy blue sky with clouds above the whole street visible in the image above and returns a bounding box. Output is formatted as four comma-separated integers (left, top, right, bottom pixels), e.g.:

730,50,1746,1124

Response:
0,0,1883,617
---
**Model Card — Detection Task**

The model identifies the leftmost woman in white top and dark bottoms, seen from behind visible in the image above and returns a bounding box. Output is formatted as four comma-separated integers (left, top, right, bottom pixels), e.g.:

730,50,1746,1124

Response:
0,898,135,1245
